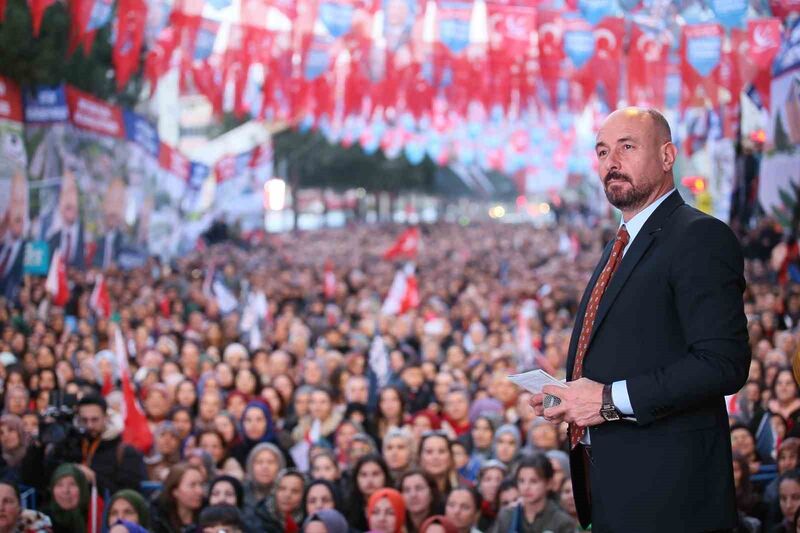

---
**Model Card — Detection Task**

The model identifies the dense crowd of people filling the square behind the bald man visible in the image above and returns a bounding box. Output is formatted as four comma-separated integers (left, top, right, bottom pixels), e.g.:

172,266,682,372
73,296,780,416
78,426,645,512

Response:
0,215,800,533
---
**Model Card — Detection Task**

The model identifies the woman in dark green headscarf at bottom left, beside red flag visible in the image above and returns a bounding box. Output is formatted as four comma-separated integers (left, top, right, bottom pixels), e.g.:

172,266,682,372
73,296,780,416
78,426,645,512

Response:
44,463,103,533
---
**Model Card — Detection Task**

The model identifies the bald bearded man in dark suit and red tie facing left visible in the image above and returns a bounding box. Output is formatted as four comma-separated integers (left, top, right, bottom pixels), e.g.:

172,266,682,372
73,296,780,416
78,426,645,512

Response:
531,108,750,533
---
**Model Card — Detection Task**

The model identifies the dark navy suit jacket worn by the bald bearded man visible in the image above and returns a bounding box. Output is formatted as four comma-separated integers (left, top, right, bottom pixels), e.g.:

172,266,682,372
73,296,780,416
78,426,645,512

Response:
567,192,750,533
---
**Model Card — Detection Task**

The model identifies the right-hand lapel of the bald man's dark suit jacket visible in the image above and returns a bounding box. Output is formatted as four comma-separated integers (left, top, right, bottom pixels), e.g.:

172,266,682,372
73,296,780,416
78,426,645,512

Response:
587,191,683,350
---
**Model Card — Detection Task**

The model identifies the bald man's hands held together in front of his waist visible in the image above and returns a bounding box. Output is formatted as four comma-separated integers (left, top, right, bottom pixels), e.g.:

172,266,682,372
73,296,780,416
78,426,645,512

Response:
531,378,604,427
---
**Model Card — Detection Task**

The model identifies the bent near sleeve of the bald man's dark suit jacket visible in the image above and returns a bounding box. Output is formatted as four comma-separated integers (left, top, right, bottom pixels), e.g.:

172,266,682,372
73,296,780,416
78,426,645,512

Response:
627,217,750,425
